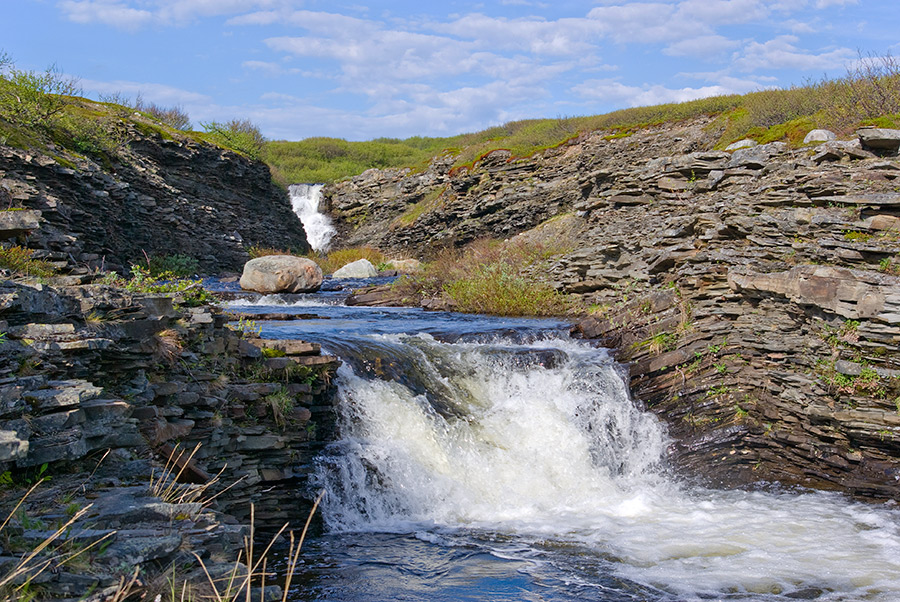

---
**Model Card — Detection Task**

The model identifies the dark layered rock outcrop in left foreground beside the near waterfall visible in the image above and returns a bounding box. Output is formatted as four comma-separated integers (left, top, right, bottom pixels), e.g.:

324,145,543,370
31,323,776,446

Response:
0,274,339,600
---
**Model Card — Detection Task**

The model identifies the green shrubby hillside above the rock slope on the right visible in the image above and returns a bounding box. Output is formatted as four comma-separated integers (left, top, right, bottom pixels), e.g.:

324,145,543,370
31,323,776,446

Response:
264,56,900,183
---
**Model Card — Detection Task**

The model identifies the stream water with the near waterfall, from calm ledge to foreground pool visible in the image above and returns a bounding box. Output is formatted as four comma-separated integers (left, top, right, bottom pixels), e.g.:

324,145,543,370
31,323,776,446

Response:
223,284,900,602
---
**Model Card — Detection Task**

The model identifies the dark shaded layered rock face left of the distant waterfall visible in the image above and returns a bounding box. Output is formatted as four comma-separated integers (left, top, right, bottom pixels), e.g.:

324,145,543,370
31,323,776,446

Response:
0,130,308,273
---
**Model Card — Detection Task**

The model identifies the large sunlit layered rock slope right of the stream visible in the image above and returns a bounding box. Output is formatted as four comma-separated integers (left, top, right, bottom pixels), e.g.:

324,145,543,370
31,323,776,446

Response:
326,120,900,499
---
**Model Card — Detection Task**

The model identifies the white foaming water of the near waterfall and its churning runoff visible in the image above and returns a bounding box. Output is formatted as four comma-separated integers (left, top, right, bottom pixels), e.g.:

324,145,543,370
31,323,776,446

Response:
319,335,900,602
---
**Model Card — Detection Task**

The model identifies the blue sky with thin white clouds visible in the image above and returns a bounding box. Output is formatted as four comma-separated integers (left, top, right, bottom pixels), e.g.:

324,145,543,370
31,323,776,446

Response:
7,0,900,140
